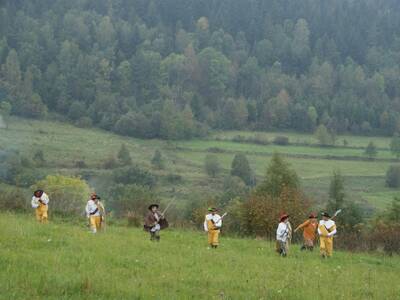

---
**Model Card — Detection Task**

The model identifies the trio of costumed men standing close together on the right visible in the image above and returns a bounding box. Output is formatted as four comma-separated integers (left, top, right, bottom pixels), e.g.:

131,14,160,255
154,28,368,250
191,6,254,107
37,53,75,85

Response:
276,212,337,258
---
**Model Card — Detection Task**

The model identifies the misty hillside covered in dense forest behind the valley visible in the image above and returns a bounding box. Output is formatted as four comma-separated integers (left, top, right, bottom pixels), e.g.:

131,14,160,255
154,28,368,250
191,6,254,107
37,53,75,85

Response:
0,0,400,139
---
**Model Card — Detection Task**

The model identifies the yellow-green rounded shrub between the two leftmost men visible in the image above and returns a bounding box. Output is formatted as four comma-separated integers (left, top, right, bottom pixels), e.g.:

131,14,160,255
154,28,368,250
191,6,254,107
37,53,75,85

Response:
31,175,90,215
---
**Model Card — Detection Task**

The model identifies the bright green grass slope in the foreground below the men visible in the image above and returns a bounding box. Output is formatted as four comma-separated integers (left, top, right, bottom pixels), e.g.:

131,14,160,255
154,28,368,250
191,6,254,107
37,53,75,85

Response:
0,214,400,300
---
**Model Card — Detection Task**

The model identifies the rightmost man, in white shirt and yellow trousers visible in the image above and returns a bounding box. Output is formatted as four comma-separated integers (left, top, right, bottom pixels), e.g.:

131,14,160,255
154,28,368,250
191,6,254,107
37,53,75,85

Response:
318,212,336,258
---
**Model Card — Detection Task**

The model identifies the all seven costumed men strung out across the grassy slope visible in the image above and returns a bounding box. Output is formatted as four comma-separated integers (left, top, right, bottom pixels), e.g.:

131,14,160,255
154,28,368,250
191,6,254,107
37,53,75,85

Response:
32,190,336,258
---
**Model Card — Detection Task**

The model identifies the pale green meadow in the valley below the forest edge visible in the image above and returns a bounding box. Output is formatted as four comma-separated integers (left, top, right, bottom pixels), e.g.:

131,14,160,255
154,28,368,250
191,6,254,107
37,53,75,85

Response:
0,118,399,210
